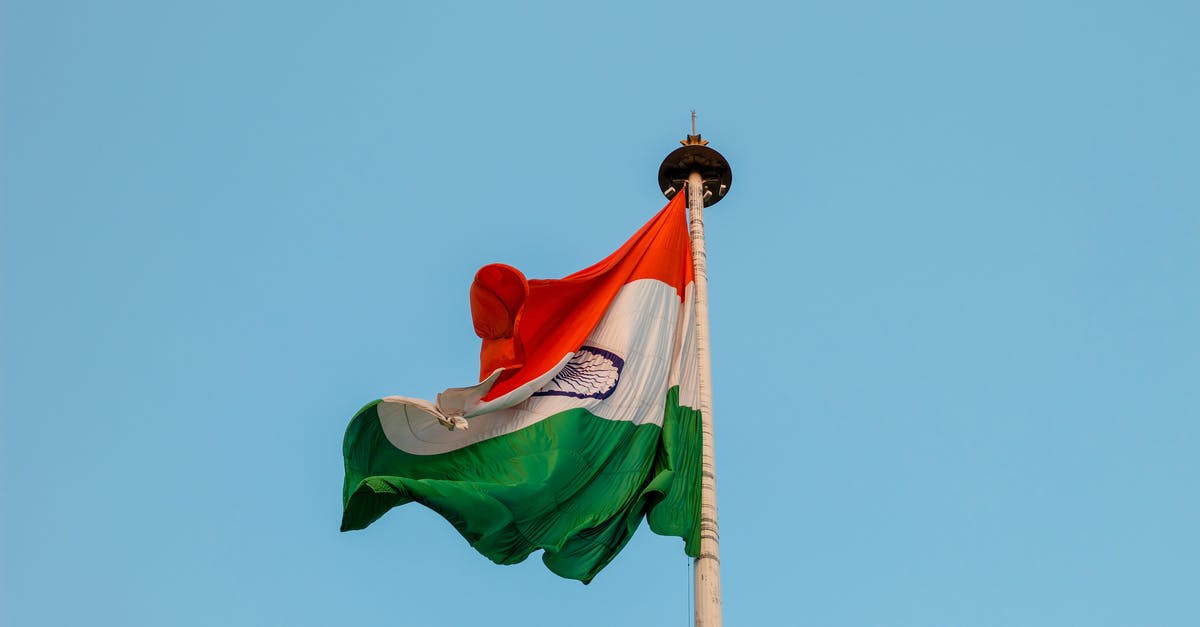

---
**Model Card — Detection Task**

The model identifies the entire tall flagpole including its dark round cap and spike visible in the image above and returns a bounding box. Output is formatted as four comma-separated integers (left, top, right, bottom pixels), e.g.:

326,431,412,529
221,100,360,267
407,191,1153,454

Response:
659,112,733,627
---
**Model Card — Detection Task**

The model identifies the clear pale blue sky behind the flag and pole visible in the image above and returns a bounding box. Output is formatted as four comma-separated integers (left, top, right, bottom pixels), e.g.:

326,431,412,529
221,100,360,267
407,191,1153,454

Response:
0,0,1200,627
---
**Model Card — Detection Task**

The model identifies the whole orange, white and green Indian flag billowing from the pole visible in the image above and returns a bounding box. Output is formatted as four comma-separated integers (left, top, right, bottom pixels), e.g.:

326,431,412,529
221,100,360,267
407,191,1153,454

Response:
342,193,701,583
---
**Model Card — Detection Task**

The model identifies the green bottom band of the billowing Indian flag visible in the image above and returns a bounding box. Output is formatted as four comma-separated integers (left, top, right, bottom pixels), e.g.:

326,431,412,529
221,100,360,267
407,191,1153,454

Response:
342,387,701,584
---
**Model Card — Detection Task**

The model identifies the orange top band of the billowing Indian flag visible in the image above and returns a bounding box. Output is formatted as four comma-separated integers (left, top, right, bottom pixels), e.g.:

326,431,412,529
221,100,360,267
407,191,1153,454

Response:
470,193,694,401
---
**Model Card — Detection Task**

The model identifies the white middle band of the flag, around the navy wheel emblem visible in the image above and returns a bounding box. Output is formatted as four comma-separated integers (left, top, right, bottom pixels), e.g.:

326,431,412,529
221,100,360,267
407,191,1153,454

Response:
378,279,696,455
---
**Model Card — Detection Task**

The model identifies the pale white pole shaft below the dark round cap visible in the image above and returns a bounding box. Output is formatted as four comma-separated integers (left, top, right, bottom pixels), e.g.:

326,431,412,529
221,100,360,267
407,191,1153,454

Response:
688,172,721,627
